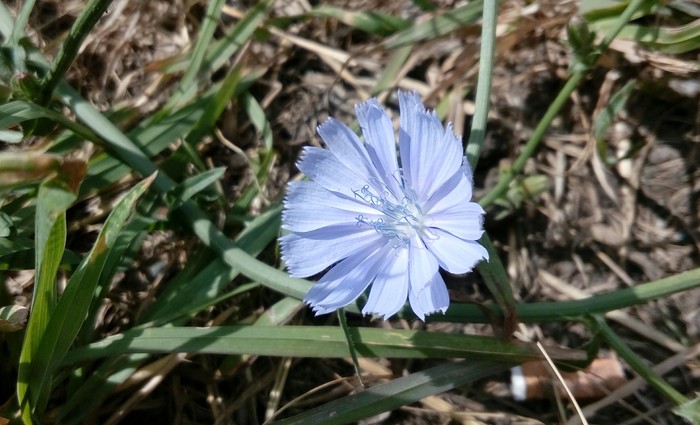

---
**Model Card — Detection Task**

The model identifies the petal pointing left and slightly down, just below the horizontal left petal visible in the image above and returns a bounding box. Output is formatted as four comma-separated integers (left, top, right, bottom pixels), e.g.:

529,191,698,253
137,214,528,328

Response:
279,223,385,277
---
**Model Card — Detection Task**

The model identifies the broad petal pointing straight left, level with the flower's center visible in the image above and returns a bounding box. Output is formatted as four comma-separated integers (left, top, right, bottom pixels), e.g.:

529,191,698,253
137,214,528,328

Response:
282,181,380,232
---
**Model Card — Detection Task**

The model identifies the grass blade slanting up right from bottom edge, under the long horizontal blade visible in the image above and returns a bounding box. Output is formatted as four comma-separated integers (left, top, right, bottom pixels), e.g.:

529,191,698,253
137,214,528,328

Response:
272,360,515,425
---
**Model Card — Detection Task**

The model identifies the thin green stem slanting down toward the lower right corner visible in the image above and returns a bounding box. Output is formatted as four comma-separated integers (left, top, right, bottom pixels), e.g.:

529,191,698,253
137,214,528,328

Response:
593,315,688,405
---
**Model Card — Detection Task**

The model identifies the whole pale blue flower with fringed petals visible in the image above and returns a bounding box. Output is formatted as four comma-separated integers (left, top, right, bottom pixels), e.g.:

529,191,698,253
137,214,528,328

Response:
280,92,488,319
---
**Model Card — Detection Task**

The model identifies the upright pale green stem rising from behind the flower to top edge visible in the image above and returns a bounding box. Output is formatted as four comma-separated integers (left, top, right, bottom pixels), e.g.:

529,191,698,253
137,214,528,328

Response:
466,0,498,170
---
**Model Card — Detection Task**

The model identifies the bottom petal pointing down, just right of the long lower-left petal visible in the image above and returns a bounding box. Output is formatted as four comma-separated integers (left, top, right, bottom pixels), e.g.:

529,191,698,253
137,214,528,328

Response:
362,243,408,318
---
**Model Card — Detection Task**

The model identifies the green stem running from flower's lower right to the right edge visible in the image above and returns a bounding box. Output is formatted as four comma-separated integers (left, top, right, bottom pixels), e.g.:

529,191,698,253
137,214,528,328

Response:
438,268,700,323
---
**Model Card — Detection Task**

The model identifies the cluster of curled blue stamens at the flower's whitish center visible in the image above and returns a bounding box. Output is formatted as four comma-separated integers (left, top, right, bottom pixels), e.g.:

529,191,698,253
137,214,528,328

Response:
353,185,428,248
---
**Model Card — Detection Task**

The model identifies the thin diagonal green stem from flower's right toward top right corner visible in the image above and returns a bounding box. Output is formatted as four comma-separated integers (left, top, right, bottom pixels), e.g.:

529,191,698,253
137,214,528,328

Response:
477,0,650,207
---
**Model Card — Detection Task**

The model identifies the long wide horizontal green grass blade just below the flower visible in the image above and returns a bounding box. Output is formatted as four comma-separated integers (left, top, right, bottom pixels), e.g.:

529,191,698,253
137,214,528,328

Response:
64,326,586,365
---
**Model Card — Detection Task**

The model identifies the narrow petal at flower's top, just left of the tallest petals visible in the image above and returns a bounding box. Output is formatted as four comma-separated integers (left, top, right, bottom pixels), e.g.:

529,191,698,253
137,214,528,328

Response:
355,99,400,194
